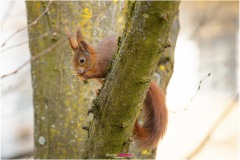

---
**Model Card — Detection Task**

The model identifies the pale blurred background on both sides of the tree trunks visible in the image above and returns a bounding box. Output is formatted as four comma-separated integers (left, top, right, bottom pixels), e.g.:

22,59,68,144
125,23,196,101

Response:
0,0,239,160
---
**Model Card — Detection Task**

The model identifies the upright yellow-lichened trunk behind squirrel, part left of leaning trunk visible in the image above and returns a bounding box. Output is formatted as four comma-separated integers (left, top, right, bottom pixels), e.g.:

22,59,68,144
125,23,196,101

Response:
26,1,124,159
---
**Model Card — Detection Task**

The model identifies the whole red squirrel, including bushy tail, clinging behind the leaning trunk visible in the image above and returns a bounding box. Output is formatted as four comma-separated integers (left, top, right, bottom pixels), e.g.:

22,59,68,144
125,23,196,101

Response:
66,28,168,149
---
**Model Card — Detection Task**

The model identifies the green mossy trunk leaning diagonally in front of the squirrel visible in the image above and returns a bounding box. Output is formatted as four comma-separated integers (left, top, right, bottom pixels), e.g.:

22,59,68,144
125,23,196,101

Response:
84,1,180,158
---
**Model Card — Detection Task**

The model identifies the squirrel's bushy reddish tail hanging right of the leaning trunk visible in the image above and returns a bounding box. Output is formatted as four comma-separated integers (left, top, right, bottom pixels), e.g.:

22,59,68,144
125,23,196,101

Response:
134,82,168,148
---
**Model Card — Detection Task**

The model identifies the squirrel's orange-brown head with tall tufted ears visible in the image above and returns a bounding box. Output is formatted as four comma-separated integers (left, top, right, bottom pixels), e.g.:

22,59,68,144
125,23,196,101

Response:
66,28,95,75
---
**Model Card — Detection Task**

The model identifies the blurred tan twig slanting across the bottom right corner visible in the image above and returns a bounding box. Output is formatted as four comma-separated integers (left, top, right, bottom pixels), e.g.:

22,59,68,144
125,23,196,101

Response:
187,94,239,159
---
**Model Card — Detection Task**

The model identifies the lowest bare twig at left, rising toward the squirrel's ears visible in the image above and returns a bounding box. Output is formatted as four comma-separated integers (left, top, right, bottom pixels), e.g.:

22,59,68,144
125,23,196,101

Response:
1,38,66,79
